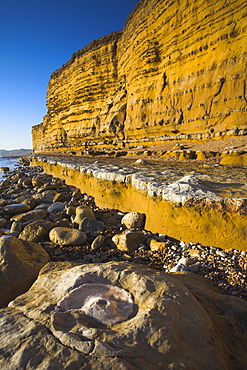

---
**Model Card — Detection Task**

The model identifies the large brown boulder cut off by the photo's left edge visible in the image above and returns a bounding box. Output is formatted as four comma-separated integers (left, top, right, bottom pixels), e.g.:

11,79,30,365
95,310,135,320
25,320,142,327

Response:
0,235,50,307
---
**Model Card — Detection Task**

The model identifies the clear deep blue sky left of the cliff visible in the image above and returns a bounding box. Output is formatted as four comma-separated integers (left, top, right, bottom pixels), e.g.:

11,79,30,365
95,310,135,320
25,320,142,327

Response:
0,0,138,149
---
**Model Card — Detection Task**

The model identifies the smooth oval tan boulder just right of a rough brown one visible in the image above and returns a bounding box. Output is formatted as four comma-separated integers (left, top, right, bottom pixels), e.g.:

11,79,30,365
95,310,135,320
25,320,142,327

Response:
49,227,87,245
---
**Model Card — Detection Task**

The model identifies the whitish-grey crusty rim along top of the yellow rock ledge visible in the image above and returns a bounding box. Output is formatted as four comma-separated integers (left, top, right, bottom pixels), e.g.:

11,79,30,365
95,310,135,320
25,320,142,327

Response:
34,155,246,205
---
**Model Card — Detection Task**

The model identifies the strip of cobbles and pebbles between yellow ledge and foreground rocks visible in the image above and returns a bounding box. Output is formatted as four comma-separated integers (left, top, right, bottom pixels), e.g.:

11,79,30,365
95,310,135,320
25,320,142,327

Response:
0,159,247,299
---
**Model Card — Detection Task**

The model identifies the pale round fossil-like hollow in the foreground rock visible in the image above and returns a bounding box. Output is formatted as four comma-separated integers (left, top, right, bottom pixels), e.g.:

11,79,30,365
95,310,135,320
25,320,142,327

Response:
57,284,133,325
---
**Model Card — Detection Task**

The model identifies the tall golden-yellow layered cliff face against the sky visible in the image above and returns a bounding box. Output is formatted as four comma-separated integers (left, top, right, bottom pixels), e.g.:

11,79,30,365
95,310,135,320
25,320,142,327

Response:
32,0,247,151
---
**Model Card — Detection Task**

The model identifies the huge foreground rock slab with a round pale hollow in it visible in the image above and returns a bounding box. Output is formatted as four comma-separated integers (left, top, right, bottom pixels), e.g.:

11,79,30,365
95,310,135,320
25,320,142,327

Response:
0,262,247,370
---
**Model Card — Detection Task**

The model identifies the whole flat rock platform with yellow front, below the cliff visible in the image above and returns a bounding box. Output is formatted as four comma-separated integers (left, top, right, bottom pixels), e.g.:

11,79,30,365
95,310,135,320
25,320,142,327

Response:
31,146,247,250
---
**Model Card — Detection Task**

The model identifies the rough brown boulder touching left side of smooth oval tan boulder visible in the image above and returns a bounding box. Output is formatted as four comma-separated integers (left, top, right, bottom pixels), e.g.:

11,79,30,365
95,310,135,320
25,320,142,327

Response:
19,220,55,243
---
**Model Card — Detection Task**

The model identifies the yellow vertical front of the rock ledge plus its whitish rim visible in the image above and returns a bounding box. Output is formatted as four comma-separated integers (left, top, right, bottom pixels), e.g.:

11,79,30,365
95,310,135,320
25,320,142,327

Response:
32,156,247,250
